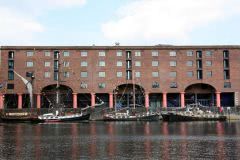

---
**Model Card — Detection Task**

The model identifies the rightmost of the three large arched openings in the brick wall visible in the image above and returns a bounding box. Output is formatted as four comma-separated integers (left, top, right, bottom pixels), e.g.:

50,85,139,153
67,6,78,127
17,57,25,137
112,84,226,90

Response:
185,83,216,106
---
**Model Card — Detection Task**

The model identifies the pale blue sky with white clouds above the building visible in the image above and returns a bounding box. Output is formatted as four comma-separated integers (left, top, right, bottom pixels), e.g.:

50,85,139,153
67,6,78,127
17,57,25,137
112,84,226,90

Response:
0,0,240,46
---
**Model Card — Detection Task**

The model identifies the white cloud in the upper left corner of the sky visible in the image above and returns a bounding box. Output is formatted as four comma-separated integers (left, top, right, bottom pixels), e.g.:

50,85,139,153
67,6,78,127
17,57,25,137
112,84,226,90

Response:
0,0,86,45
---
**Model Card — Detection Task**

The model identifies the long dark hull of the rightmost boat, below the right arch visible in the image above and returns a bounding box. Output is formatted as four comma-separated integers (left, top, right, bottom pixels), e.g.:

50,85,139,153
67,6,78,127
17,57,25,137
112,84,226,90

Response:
162,113,227,122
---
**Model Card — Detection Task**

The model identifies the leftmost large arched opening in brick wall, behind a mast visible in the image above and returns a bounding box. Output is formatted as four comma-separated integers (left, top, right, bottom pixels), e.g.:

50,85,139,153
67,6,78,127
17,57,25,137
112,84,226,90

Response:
41,84,73,108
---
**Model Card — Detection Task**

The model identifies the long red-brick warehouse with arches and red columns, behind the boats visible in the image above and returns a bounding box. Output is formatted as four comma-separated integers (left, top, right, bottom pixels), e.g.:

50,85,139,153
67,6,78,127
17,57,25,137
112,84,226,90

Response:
0,45,240,109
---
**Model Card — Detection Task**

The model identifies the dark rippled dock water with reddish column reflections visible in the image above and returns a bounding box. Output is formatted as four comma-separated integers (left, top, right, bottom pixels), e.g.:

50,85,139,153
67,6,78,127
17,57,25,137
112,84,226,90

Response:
0,122,240,159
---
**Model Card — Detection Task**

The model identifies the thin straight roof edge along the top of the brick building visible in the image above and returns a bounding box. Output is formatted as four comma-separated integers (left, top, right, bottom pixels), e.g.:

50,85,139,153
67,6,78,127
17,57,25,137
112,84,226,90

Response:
0,45,240,50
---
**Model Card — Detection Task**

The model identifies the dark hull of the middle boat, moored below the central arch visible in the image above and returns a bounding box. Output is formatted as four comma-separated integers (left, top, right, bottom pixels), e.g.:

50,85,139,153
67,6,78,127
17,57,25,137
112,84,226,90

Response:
103,114,159,121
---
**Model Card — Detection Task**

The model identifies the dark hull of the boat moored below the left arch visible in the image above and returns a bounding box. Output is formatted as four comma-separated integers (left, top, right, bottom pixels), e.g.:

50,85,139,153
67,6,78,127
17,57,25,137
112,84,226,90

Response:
32,113,90,123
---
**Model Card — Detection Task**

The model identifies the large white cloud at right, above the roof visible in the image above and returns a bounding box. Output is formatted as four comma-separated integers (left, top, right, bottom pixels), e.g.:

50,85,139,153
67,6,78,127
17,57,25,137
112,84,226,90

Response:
102,0,240,43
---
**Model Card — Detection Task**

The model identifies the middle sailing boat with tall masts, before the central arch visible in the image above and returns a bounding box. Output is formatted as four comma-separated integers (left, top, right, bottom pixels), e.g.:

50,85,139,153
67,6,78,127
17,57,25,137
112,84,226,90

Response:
103,70,159,121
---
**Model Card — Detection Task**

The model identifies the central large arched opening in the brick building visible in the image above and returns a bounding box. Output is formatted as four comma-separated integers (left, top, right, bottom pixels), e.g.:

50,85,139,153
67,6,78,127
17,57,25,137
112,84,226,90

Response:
113,84,145,110
